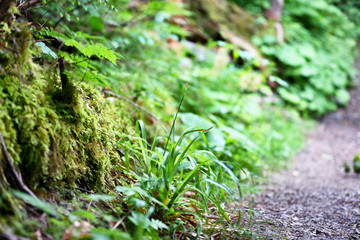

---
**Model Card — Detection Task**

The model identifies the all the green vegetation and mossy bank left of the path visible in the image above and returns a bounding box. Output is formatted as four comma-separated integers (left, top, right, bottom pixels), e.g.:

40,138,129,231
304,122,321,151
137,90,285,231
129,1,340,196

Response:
0,0,357,239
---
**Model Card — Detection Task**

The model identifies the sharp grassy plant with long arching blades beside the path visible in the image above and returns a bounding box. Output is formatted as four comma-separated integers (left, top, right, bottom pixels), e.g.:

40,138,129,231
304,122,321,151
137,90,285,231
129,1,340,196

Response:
109,86,240,235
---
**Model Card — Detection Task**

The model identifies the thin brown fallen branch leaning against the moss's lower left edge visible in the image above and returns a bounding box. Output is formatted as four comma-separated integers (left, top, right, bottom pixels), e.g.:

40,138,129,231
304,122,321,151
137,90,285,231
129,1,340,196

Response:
0,131,38,199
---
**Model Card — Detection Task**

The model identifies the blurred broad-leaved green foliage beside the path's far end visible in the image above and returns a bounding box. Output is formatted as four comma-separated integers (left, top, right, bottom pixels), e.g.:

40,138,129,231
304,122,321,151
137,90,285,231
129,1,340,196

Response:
238,0,359,116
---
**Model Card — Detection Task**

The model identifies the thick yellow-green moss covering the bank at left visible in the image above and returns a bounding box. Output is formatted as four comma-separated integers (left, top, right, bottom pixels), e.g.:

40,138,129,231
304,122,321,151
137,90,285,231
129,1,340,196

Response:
0,21,135,193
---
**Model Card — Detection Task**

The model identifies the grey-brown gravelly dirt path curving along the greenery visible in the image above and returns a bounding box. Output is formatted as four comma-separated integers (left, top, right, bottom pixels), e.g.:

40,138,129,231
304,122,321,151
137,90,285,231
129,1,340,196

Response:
240,54,360,239
